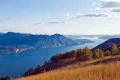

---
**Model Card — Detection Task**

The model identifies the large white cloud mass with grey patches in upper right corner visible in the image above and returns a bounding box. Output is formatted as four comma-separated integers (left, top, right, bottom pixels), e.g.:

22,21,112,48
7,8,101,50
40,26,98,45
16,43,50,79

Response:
92,0,120,17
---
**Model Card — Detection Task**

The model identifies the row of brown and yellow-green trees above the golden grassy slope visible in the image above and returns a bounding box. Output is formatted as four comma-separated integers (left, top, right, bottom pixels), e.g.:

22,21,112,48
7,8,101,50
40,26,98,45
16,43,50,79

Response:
50,44,120,62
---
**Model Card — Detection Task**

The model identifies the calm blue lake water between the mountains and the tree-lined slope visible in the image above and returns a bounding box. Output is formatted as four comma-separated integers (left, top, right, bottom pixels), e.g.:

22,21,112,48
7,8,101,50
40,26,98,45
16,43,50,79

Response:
0,38,104,77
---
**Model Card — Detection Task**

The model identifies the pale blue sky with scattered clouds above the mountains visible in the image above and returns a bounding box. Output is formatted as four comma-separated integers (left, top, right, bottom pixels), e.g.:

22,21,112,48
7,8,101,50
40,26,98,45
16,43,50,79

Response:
0,0,120,35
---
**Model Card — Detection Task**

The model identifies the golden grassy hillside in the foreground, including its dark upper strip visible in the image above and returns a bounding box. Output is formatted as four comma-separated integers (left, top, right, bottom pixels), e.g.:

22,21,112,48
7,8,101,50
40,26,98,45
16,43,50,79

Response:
18,56,120,80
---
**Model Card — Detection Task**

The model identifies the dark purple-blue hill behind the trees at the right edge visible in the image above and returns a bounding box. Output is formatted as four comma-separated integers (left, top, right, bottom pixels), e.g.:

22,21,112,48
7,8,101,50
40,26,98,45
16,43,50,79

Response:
93,38,120,50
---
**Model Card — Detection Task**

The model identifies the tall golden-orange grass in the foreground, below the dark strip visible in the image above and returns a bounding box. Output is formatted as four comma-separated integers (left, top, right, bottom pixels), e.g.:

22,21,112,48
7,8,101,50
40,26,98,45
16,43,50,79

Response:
18,62,120,80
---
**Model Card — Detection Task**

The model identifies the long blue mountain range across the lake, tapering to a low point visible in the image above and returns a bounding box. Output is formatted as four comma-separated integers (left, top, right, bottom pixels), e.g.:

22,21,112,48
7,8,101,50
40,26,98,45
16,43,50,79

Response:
0,32,92,53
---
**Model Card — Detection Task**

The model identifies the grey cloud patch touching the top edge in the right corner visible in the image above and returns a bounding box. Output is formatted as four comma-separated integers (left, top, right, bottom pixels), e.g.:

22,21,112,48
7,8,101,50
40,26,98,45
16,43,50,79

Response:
101,0,120,8
